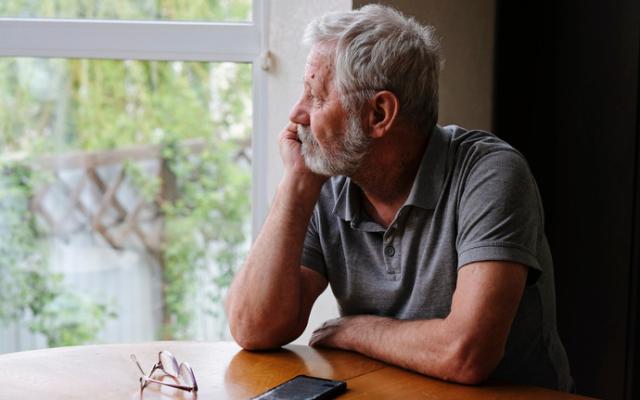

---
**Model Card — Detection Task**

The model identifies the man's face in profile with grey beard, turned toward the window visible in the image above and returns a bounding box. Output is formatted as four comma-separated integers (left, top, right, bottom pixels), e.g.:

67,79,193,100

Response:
289,45,370,176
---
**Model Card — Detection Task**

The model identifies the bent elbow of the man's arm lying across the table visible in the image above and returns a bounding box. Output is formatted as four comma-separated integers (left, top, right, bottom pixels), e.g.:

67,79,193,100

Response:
445,342,504,385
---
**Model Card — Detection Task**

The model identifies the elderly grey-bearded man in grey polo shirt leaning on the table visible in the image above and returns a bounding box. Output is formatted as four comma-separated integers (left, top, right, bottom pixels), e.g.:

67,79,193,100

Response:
226,5,572,390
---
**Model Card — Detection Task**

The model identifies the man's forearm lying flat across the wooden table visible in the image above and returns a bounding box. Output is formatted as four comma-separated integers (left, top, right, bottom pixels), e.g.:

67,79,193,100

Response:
318,315,502,384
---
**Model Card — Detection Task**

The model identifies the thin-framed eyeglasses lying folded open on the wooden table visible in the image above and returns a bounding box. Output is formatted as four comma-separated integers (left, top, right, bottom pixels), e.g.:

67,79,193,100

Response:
131,350,198,392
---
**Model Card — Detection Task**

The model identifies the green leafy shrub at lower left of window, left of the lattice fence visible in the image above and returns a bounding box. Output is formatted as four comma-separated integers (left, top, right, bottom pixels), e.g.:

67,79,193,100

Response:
0,164,113,346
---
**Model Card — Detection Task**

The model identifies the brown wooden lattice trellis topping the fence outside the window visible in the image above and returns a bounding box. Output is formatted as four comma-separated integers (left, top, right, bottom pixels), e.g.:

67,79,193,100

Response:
30,142,202,257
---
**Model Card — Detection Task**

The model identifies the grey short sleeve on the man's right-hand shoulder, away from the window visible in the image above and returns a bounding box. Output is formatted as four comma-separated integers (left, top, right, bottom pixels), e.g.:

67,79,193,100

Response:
456,150,544,283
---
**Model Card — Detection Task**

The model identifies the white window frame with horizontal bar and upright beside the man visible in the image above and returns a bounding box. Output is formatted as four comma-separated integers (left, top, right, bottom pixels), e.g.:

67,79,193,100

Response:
0,0,268,238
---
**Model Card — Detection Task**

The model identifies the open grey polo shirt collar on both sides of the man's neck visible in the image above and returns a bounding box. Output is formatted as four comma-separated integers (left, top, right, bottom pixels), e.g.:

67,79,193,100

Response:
333,126,450,225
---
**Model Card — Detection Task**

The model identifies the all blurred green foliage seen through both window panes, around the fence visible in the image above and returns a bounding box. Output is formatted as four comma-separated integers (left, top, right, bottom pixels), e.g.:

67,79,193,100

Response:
0,0,252,346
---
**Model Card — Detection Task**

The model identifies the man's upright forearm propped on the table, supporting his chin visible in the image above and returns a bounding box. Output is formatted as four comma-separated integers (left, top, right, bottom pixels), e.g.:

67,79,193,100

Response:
226,177,321,348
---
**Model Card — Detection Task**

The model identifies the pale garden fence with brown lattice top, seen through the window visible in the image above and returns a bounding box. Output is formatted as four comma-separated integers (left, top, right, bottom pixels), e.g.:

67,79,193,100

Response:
0,141,242,353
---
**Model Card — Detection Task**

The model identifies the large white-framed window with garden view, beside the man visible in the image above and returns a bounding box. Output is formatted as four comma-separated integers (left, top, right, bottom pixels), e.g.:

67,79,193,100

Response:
0,0,266,352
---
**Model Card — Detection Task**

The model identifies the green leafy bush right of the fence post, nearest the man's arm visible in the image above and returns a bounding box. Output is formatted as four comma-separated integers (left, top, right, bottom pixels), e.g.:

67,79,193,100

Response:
163,138,250,339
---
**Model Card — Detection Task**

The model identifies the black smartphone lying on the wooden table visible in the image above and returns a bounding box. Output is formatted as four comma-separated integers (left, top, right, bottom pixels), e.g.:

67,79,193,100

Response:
252,375,347,400
